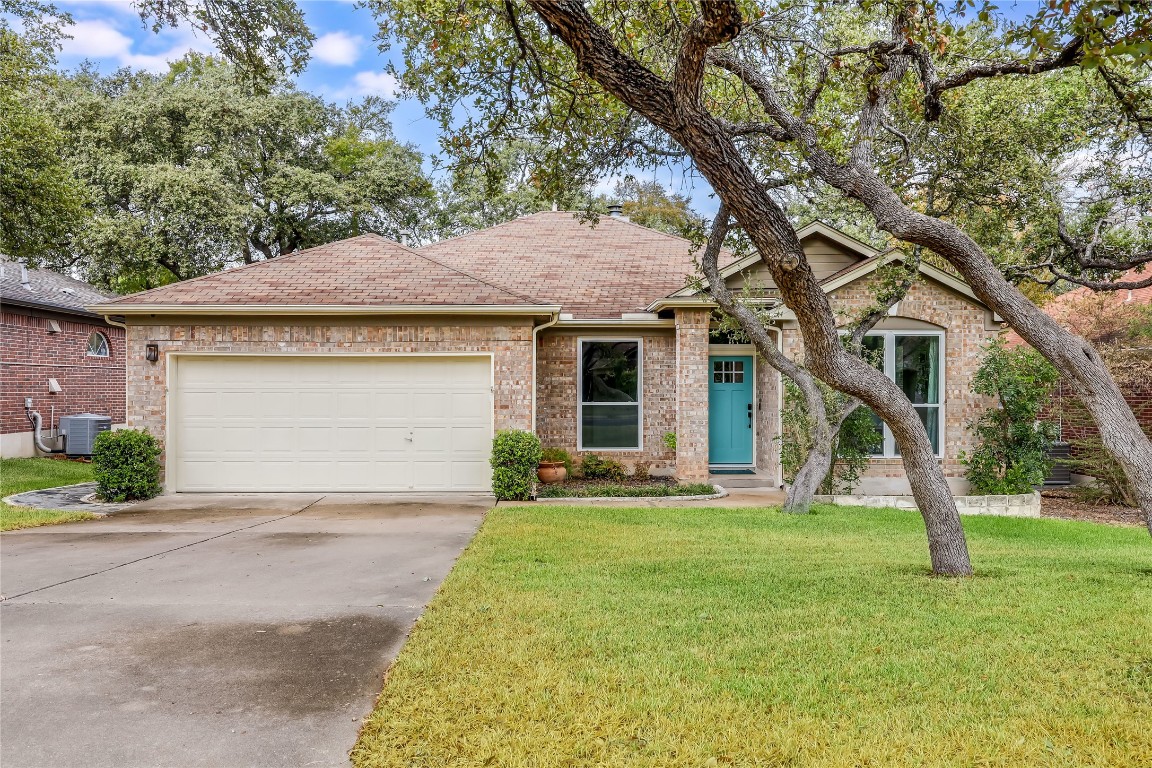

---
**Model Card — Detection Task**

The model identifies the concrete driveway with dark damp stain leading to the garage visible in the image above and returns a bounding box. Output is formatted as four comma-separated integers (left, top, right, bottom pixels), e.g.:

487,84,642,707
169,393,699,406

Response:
0,494,491,768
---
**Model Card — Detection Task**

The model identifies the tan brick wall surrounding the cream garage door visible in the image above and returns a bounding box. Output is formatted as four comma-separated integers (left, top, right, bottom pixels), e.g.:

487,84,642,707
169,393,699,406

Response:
127,319,532,469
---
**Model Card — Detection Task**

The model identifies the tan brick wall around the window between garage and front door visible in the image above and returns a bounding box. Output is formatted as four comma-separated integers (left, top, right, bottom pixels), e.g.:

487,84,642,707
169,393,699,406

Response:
536,330,676,472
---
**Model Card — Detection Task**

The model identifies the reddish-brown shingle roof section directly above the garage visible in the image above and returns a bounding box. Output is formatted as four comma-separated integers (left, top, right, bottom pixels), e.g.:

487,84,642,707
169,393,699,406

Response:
105,235,539,311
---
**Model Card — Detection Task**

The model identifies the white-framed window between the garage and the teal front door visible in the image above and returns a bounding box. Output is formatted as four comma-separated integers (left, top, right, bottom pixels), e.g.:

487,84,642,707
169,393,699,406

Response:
577,341,641,450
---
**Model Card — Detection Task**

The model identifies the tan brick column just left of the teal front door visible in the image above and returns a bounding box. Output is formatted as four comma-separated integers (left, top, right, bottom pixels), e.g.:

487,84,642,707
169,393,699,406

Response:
676,307,712,482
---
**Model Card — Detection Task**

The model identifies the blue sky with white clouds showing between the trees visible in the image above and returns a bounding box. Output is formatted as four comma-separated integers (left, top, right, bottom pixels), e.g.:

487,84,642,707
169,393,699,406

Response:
44,0,1037,215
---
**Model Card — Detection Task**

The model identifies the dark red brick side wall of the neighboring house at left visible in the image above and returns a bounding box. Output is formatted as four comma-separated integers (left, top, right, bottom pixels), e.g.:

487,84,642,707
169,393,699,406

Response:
0,307,124,434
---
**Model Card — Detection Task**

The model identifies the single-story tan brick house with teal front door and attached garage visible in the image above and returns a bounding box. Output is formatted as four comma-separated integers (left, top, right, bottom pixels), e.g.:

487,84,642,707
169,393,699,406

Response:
89,212,999,492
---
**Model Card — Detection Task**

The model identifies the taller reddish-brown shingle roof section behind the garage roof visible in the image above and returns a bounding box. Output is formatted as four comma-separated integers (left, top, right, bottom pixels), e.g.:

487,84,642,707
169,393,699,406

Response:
419,211,709,318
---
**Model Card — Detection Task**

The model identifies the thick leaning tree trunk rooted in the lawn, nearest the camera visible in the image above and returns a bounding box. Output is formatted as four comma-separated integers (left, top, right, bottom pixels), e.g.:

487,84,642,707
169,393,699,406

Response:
529,0,972,576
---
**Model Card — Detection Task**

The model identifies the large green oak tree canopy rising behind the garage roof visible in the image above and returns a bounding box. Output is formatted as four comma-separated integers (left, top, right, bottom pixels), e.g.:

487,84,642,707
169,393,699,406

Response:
44,53,433,290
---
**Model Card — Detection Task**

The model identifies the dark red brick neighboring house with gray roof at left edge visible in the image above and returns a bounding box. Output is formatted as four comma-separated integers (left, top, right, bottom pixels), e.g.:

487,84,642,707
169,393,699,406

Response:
0,260,124,458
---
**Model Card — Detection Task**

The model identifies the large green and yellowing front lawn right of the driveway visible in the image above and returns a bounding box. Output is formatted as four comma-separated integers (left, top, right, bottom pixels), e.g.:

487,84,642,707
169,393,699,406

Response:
353,505,1152,768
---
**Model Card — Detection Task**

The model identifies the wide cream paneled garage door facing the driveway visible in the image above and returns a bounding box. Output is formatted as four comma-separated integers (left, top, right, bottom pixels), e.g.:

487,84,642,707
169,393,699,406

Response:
168,356,492,492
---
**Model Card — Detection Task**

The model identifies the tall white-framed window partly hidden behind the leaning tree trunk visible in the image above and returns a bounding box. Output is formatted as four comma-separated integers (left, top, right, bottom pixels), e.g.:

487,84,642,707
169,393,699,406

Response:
864,332,943,457
